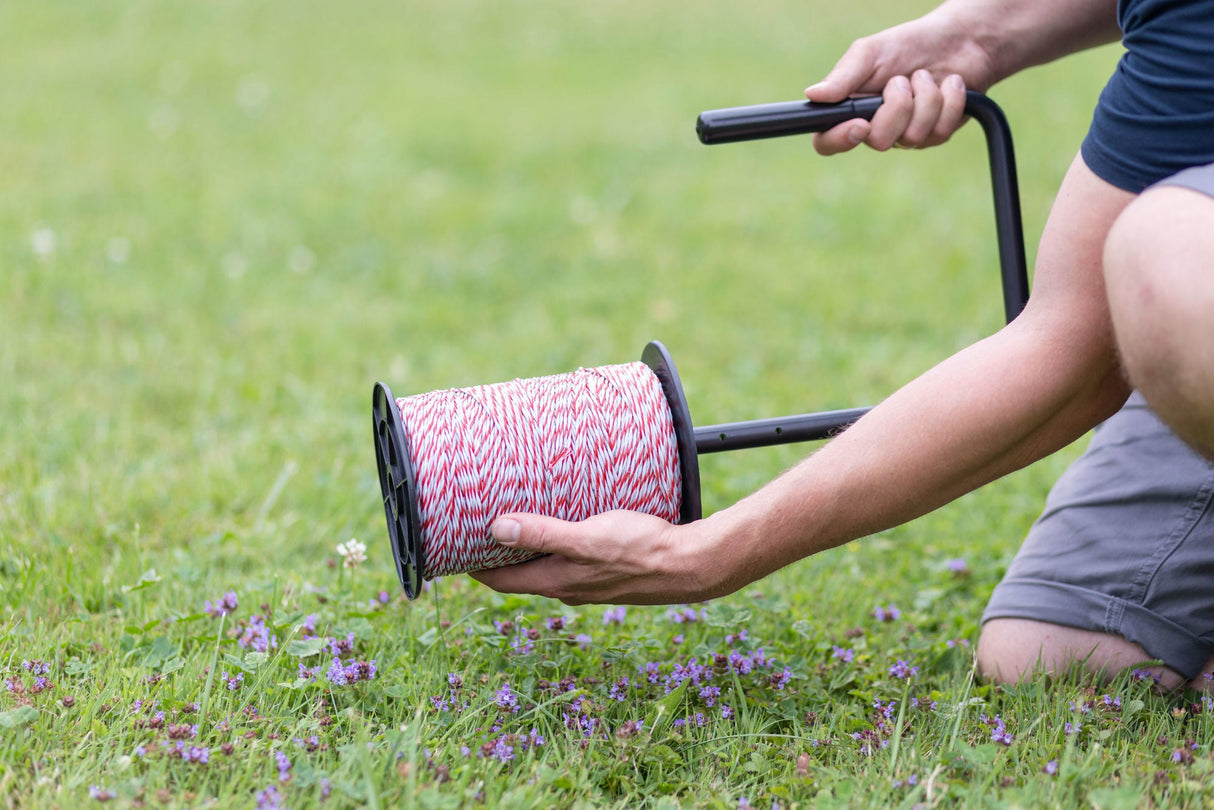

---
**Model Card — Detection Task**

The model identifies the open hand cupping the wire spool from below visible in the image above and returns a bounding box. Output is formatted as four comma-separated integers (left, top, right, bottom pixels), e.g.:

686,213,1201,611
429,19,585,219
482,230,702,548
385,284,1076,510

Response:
472,511,742,605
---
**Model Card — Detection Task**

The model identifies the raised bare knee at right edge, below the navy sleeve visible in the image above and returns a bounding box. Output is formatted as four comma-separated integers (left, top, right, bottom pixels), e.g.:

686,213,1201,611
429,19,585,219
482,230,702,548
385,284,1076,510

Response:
1104,186,1214,459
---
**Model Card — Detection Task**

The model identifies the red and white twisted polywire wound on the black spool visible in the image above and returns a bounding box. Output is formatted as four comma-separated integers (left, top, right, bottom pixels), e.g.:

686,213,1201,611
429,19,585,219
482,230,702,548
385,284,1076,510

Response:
396,363,682,579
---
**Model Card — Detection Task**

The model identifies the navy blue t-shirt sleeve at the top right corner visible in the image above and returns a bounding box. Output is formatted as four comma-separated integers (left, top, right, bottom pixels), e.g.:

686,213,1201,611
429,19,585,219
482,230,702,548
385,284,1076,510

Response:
1082,0,1214,192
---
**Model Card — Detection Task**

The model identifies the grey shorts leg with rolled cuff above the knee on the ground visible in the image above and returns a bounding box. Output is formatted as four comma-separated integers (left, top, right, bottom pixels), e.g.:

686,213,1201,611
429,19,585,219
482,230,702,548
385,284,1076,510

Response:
982,392,1214,678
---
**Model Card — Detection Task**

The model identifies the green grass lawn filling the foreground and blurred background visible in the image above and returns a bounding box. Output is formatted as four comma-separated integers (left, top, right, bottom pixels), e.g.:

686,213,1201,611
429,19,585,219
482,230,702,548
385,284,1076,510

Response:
0,0,1212,808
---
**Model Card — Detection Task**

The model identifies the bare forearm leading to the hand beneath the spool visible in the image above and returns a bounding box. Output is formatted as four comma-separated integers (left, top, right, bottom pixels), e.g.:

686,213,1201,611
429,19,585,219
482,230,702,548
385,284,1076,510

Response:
709,313,1128,590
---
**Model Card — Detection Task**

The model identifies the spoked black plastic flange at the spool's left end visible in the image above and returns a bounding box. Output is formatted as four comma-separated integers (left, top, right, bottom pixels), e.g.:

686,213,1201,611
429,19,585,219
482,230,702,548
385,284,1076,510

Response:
371,383,425,599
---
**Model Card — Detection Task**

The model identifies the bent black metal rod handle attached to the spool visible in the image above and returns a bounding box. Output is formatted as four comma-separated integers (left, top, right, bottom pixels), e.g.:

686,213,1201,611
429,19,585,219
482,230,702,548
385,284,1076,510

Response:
694,90,1028,453
